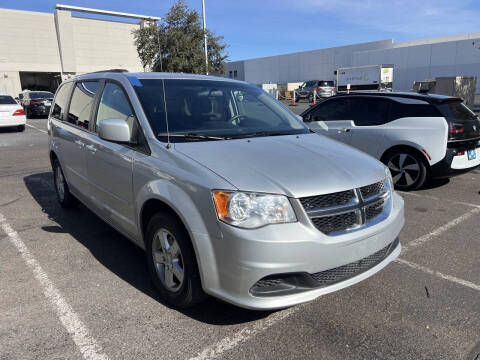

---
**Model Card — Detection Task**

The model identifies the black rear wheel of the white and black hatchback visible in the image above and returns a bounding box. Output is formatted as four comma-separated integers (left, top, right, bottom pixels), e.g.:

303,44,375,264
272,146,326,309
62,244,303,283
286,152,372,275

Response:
384,149,427,191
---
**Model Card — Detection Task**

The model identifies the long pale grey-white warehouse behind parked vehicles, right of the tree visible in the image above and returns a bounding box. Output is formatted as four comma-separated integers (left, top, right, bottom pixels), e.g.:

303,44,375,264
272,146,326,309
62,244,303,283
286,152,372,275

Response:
226,33,480,93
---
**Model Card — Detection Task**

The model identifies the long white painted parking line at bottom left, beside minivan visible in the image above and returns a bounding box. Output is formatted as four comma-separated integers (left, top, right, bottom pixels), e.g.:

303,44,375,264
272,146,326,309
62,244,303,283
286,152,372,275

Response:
0,214,108,360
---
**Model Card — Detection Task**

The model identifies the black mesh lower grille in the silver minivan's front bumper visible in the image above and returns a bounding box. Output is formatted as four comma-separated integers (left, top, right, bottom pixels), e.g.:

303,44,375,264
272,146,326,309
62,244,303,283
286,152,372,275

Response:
311,239,398,287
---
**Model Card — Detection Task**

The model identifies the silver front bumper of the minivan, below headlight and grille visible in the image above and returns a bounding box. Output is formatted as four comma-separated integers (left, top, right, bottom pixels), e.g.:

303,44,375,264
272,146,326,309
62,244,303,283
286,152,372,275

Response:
205,193,404,310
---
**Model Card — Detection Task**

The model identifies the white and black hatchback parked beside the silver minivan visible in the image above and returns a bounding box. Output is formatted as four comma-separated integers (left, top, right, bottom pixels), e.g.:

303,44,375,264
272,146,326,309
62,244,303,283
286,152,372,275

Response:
301,92,480,190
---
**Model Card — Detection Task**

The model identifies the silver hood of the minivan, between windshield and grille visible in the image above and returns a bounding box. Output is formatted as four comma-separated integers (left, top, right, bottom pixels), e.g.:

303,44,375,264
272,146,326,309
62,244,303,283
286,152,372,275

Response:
175,134,385,197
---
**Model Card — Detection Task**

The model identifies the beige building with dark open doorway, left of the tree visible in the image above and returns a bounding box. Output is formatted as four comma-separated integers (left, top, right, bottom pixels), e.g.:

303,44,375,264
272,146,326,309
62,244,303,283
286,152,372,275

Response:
0,5,160,96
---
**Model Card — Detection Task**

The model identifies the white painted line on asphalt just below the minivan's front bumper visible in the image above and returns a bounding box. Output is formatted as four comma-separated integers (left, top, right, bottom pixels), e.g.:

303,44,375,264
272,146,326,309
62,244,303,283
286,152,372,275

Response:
189,305,302,360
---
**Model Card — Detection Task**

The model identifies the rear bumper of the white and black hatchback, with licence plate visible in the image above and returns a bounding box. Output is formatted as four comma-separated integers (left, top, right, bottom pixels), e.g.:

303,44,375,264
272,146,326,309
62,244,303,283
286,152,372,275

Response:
431,145,480,178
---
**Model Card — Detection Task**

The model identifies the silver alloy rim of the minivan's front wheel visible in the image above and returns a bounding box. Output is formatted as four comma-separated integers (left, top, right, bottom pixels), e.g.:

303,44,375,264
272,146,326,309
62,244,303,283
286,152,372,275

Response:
152,229,185,292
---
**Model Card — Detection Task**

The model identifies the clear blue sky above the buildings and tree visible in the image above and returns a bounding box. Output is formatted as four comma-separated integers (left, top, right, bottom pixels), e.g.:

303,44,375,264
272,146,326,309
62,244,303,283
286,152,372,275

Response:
0,0,480,60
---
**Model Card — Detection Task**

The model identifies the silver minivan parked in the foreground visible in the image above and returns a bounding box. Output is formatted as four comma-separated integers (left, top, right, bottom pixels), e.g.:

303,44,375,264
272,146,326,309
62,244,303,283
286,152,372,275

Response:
48,72,404,309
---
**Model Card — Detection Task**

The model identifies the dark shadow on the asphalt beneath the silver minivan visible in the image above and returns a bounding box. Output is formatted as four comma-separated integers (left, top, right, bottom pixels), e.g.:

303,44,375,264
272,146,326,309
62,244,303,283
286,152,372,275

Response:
23,172,271,325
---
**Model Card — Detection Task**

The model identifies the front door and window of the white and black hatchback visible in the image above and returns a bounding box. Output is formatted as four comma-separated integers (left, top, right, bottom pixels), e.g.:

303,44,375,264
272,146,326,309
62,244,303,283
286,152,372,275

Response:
304,98,354,144
